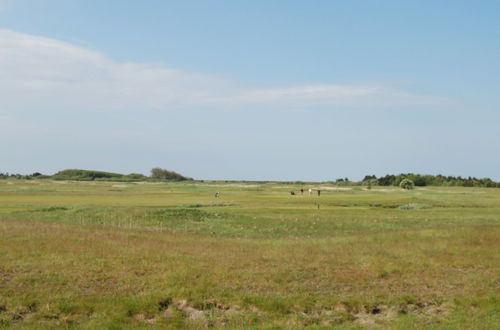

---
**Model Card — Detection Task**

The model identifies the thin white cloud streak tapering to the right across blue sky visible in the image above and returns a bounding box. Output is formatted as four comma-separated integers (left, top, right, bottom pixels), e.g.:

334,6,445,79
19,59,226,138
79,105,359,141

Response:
0,28,452,109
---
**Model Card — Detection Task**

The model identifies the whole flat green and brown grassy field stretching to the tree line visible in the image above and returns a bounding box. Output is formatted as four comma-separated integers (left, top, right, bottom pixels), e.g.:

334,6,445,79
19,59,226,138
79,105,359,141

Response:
0,180,500,329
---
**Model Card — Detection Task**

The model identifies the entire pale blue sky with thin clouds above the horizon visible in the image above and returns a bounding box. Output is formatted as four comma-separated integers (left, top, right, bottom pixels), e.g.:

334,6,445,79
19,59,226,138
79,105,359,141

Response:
0,0,500,181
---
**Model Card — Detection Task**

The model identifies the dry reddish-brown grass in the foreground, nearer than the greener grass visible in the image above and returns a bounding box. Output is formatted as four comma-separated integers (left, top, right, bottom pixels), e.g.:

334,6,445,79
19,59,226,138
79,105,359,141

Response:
0,221,500,326
